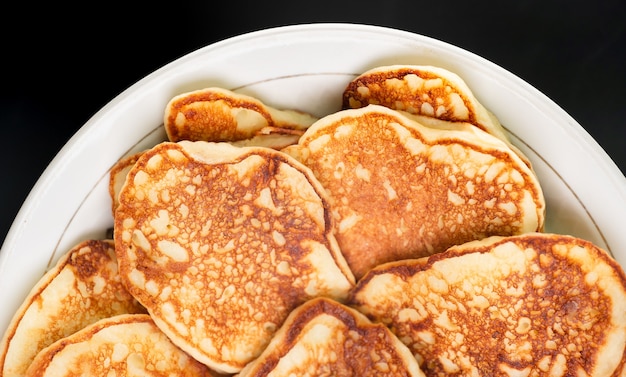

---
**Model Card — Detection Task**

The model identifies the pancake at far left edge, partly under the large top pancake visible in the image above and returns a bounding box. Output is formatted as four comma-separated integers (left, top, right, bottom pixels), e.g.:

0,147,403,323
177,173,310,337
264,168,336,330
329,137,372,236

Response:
0,240,145,377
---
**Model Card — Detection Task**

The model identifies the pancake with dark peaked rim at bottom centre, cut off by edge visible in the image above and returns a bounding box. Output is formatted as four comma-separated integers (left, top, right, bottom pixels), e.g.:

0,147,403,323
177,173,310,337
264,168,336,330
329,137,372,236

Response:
238,298,424,377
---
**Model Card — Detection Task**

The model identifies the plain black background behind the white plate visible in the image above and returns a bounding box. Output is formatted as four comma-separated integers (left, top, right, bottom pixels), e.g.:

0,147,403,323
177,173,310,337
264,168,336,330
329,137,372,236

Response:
0,0,626,247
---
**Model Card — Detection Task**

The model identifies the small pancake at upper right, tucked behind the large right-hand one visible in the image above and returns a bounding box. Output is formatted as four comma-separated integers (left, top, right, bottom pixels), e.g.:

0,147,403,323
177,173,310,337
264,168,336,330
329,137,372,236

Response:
343,65,531,166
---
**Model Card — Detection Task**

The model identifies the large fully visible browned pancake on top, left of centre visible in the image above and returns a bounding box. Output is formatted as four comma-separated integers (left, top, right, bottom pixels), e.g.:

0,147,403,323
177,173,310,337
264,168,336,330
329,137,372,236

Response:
114,141,354,373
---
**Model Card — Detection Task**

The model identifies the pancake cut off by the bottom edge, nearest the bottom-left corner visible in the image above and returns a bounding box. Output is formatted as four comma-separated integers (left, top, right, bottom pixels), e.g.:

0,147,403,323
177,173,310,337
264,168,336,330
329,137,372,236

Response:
26,314,217,377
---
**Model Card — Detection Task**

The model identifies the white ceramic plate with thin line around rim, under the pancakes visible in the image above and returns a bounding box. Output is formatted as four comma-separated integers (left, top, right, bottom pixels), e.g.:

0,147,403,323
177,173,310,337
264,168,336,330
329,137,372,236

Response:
0,24,626,334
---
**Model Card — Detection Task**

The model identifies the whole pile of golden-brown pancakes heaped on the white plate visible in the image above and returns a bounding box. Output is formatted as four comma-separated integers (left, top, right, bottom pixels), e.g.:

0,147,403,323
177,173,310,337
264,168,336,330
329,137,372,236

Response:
0,66,626,376
